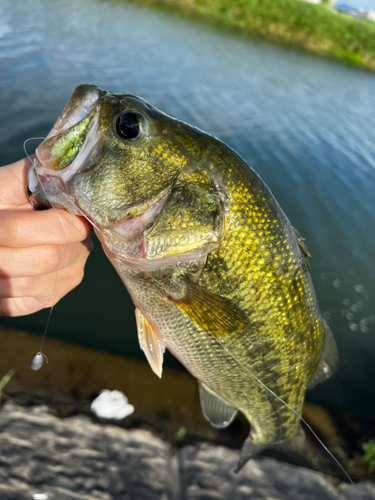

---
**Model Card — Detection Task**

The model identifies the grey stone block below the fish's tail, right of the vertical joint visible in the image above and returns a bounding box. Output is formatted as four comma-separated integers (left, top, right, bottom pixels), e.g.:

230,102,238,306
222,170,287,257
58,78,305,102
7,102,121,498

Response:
180,444,342,500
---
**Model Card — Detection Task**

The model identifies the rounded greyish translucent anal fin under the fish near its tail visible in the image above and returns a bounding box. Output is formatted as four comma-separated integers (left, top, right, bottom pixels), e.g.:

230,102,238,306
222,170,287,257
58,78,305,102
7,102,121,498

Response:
198,382,237,429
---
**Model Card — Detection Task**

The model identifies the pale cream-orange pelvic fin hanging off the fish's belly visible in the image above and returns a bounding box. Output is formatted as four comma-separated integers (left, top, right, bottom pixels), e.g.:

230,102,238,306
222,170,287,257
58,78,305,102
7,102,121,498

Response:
135,307,165,378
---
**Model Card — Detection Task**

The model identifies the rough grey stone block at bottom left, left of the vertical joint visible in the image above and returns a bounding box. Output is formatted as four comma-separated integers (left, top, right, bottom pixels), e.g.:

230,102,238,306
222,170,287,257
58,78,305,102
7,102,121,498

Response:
0,403,169,500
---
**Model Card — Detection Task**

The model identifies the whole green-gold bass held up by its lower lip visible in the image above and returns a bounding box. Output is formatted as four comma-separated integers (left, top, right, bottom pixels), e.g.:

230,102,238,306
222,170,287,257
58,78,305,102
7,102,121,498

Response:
27,84,338,471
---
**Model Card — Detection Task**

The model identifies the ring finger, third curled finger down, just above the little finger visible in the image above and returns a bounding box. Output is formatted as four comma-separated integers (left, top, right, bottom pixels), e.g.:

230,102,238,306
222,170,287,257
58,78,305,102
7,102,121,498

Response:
0,262,85,301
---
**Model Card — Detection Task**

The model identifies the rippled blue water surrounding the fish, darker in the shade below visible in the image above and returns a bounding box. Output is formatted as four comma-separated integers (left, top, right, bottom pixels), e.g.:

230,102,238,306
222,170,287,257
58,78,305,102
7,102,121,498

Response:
0,0,375,415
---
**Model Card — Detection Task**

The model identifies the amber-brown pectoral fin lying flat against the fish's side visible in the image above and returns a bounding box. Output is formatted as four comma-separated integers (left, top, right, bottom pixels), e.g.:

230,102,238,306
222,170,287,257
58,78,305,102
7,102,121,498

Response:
172,278,249,337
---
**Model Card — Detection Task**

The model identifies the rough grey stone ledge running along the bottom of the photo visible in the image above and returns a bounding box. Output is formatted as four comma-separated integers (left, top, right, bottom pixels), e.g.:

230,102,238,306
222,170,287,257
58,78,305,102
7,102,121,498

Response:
0,402,375,500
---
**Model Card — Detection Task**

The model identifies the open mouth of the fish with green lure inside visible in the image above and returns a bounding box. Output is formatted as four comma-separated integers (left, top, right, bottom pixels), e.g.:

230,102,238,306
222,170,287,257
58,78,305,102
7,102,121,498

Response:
27,85,107,210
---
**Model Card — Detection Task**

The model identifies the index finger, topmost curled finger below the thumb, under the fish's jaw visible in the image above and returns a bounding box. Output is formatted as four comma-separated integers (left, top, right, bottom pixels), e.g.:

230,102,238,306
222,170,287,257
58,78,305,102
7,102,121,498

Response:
0,208,92,248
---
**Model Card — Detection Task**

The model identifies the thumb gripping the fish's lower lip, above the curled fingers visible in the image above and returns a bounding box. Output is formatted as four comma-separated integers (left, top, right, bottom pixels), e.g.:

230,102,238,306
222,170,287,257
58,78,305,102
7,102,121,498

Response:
0,158,32,210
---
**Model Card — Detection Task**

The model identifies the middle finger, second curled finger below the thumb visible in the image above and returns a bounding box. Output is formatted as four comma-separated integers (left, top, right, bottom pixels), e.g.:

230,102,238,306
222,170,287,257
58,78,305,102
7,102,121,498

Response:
0,238,93,278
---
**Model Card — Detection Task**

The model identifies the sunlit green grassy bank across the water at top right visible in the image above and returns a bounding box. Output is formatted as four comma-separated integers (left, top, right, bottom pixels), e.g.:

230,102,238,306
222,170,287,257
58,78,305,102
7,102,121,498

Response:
138,0,375,70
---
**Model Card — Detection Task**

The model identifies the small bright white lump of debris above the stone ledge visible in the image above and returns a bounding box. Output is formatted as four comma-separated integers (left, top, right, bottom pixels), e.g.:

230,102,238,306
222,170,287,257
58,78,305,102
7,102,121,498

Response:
91,389,134,420
